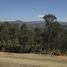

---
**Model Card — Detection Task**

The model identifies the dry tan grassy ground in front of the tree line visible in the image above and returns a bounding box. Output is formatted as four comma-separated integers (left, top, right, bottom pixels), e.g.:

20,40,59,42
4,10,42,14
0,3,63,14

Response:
0,52,67,67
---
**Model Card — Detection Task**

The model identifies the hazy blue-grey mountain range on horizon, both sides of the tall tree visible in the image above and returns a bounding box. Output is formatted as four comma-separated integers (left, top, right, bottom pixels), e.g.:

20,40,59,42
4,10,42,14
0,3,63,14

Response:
0,20,67,29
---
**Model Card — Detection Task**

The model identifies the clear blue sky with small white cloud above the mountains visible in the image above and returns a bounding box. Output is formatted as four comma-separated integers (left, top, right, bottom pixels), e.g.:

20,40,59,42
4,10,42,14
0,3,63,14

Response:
0,0,67,22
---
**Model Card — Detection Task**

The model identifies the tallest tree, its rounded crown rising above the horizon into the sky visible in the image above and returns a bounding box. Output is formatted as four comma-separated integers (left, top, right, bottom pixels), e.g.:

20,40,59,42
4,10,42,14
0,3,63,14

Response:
43,14,57,52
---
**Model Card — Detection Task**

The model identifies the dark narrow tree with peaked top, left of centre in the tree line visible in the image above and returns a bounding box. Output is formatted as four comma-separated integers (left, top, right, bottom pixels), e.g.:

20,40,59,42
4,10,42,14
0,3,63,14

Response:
19,24,29,52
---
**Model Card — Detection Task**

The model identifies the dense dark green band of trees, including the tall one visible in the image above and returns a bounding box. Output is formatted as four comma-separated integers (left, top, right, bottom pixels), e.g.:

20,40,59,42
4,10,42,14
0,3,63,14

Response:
0,14,67,53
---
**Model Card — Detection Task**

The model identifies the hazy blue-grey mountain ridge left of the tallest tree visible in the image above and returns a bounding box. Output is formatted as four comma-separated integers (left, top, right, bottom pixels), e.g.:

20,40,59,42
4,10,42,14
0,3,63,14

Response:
3,20,45,28
